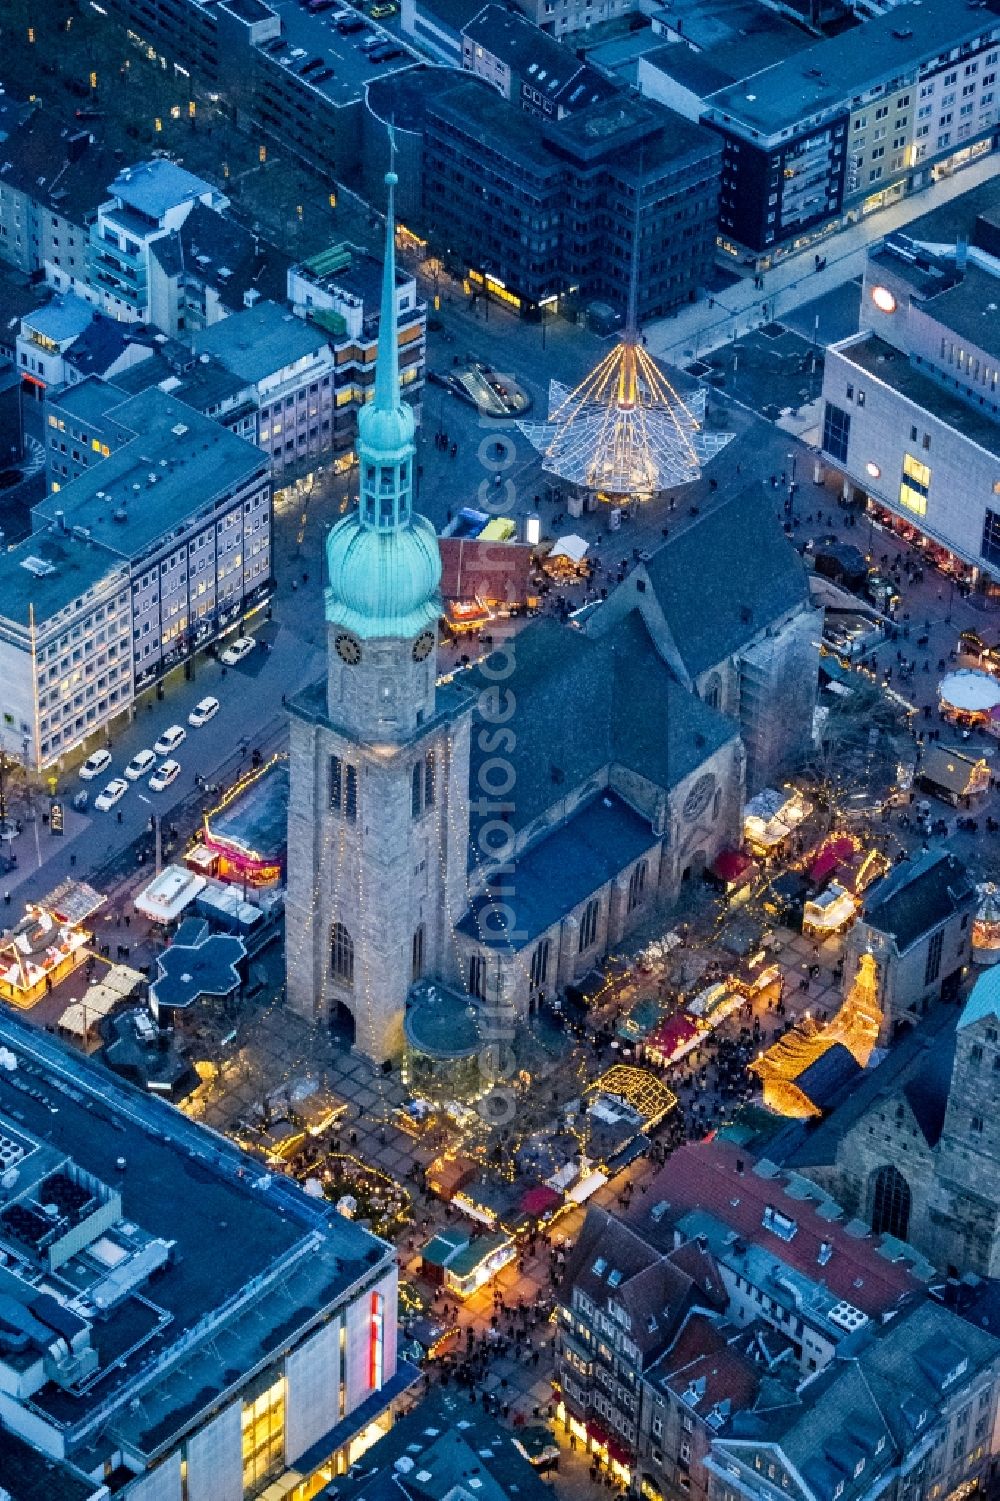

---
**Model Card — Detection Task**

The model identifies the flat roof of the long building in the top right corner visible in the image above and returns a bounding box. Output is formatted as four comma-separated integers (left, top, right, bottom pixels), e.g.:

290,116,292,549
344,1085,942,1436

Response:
706,0,1000,137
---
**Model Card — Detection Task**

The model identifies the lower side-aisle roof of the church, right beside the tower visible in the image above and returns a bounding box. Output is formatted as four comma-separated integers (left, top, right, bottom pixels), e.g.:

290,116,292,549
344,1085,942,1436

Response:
458,793,658,950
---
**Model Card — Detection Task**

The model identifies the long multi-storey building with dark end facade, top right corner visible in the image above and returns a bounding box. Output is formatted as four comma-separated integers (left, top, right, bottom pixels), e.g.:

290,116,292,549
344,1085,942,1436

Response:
640,0,1000,270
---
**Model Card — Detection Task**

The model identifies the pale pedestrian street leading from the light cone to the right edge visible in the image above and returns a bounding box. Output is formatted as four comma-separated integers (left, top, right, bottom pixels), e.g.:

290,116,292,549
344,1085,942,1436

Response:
644,155,1000,365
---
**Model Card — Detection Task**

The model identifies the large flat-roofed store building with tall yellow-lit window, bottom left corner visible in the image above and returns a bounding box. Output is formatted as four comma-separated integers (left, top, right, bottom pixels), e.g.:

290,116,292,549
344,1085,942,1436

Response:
0,1008,416,1501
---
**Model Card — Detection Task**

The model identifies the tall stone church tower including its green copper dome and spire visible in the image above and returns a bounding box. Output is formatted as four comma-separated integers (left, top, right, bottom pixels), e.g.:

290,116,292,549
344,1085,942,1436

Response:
285,158,468,1063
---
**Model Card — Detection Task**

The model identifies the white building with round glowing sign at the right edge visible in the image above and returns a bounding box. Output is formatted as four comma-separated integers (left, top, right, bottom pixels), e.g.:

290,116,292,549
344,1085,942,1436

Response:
823,215,1000,594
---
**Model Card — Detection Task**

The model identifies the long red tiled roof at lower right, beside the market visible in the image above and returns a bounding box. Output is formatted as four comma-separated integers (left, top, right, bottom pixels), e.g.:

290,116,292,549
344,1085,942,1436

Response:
626,1141,923,1318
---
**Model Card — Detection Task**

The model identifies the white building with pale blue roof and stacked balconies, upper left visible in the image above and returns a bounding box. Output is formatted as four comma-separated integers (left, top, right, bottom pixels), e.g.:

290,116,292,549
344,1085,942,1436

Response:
87,158,228,323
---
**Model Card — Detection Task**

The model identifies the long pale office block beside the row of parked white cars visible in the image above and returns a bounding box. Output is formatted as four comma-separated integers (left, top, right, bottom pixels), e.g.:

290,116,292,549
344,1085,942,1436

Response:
0,380,272,769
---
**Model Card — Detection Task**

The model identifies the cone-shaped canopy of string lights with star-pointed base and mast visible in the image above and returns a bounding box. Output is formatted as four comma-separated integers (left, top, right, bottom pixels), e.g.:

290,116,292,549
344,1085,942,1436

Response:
518,205,733,504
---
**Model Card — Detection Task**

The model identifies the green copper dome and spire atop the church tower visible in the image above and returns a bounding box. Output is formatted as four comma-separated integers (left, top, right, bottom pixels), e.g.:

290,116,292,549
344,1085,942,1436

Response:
326,141,441,651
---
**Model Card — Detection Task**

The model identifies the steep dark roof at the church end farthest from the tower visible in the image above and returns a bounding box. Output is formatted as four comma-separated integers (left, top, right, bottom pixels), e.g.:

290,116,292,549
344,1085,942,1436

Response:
639,491,809,677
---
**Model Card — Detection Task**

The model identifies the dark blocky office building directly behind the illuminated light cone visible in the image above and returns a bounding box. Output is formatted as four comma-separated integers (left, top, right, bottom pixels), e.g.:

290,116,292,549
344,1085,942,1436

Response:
422,80,721,318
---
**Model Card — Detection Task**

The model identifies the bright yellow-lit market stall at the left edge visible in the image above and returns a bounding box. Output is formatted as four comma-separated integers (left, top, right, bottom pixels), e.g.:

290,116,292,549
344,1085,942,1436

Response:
0,881,104,1010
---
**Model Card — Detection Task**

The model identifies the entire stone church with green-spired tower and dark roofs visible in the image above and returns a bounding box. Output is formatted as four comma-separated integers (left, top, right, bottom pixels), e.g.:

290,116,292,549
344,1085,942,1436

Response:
285,171,820,1064
